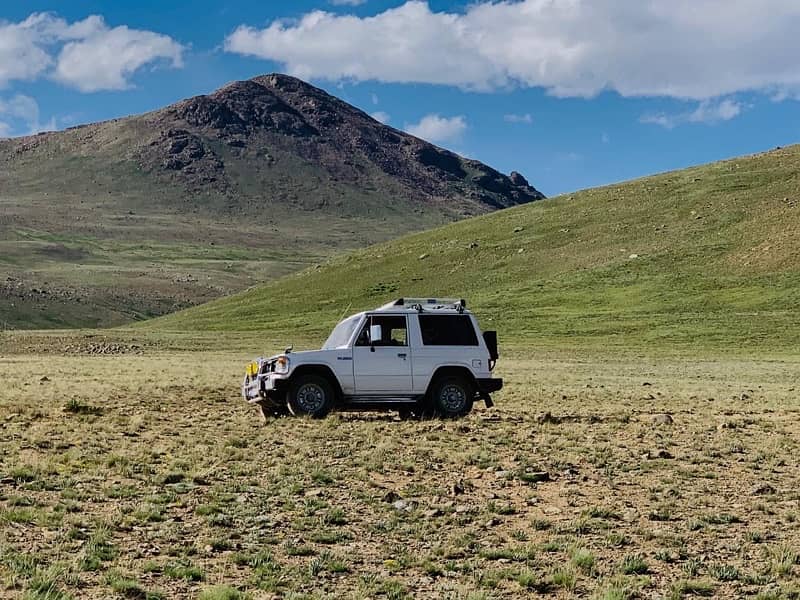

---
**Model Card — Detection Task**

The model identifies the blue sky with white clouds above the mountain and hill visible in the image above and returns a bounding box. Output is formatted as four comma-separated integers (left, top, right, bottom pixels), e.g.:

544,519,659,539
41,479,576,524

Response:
0,0,800,195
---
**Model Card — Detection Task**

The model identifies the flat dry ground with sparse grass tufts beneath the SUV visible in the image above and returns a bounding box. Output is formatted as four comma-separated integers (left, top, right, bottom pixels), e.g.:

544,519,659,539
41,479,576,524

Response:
0,344,800,600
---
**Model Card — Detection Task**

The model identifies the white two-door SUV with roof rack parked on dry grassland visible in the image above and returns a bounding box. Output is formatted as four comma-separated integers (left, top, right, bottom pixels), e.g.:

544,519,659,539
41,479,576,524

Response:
242,298,503,418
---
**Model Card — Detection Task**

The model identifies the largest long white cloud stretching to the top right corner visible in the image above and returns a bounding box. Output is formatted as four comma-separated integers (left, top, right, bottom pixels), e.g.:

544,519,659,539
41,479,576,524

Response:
225,0,800,100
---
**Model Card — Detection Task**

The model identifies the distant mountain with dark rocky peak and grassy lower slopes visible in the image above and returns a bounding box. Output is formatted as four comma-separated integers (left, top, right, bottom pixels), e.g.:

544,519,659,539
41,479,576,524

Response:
0,74,543,327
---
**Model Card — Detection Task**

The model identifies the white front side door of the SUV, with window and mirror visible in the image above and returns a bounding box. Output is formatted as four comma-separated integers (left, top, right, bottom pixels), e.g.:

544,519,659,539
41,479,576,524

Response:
353,315,412,396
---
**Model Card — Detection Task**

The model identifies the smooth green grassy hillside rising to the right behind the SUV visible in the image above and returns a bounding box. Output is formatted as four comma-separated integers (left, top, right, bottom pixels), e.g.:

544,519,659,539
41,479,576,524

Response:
149,146,800,352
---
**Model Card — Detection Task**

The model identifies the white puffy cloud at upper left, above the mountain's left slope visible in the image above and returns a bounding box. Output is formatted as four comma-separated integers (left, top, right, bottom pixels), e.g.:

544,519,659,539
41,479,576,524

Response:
0,13,183,92
